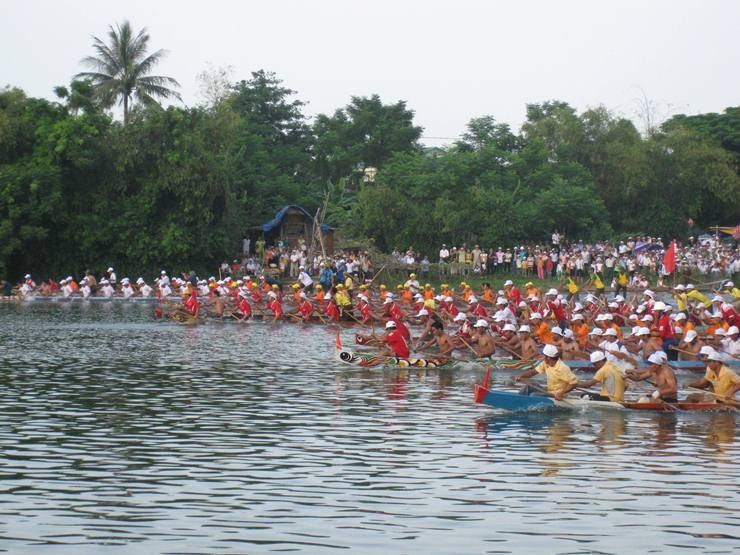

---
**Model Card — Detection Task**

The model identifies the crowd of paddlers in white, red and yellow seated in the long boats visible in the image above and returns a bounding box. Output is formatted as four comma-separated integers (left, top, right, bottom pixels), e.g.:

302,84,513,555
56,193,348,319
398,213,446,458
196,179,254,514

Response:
7,267,740,402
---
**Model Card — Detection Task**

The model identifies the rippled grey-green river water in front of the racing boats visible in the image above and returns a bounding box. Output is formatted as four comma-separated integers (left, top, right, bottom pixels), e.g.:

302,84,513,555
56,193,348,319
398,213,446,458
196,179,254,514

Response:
0,302,740,554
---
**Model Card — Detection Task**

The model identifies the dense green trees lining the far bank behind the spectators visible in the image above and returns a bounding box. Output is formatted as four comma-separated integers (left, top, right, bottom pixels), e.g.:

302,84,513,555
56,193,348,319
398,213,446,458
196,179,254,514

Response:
0,71,740,279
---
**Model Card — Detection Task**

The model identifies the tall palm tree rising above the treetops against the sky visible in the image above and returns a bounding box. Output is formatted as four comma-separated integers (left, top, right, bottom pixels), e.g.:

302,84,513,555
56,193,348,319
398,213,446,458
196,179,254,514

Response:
75,21,182,125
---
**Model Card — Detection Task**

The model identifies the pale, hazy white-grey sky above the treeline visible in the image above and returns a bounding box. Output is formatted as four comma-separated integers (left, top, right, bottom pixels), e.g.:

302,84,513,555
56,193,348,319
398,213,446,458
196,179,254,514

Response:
0,0,740,146
